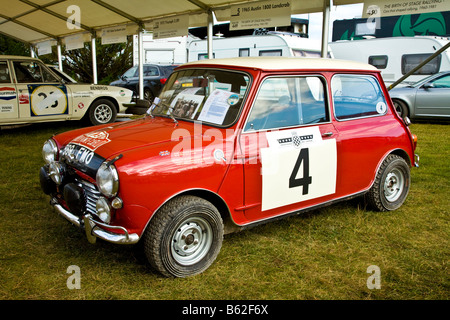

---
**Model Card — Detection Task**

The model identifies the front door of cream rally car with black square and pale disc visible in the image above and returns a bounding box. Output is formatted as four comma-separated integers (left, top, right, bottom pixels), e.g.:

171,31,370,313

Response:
12,60,72,122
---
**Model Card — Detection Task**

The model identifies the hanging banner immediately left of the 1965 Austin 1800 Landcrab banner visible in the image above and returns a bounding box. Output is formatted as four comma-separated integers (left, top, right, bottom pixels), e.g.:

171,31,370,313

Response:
153,14,189,39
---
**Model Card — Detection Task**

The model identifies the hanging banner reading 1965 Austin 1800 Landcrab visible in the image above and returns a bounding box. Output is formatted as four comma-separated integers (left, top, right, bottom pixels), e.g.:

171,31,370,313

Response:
230,0,292,30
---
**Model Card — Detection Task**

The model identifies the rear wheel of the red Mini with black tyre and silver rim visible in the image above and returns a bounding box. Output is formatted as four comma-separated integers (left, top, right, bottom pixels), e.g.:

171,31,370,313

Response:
367,154,411,211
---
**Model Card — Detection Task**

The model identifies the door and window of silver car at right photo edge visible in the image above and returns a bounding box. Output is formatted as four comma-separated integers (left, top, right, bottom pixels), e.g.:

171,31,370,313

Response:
415,74,450,117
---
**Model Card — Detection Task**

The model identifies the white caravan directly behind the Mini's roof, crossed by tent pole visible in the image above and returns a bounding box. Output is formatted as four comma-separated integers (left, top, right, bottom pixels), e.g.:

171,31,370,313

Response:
188,32,321,61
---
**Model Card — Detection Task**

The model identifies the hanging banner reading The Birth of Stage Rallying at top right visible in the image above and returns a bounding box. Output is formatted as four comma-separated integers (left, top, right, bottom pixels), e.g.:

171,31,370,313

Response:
362,0,450,18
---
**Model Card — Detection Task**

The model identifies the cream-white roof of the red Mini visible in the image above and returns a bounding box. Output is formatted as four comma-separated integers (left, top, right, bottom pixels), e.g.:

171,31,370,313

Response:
183,57,378,71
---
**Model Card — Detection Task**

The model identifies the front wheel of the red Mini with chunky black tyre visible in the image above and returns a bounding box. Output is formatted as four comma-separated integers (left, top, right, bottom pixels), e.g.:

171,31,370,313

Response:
143,196,223,277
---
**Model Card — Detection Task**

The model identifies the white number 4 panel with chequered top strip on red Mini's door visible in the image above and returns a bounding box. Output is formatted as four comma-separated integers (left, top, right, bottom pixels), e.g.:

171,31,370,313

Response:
261,127,337,211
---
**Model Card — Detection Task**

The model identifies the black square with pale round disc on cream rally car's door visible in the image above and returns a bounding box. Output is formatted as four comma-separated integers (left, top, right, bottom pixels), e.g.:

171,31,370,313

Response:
28,85,69,117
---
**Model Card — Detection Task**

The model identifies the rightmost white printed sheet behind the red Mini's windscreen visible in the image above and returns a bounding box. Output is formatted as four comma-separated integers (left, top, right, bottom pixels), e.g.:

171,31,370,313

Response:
198,89,234,124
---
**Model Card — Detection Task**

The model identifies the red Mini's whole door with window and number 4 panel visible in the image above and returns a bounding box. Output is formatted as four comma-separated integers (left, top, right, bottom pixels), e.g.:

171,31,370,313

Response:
239,75,338,221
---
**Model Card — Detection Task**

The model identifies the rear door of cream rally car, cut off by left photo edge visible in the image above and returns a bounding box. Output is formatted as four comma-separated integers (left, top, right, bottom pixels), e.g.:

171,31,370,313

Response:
0,60,19,123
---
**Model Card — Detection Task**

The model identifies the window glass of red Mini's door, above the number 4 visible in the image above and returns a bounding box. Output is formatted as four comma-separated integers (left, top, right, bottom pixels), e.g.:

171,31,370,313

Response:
244,76,329,131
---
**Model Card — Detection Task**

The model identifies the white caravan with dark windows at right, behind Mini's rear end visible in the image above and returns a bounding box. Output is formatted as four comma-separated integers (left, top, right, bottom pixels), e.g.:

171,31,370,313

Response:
329,36,450,85
